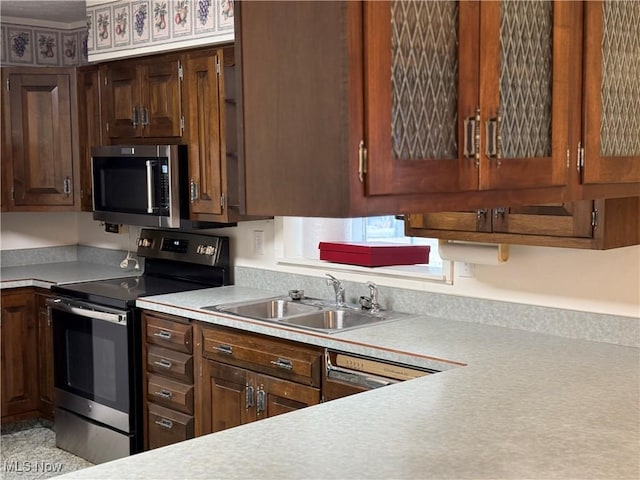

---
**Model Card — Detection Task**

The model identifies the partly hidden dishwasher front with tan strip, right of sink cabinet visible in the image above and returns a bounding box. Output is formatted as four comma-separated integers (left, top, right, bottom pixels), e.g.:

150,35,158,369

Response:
322,349,438,402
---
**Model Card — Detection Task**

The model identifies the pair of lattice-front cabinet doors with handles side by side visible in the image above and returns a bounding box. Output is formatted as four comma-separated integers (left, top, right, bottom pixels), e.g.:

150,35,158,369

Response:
364,1,579,194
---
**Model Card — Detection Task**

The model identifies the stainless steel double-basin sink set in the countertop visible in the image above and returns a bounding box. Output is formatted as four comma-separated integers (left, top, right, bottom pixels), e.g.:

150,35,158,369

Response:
202,297,413,333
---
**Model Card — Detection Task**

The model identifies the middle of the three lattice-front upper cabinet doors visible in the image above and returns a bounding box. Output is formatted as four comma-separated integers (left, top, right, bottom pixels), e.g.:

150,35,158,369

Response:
480,1,580,189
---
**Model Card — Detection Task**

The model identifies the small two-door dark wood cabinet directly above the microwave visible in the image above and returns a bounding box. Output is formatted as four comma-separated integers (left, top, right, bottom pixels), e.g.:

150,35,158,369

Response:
102,55,184,143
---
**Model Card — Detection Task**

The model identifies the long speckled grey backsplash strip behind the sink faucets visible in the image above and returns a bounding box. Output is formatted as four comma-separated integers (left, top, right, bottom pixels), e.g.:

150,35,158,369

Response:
235,266,640,348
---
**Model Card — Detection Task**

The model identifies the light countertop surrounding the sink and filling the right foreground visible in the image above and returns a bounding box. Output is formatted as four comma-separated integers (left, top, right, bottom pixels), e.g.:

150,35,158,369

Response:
51,287,640,480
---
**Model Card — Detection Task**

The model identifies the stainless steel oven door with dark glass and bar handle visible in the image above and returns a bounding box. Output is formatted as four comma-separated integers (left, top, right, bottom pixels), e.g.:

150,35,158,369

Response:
47,298,131,433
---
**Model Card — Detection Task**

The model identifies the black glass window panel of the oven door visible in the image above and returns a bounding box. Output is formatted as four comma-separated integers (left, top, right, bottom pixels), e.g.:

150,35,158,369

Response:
53,311,129,412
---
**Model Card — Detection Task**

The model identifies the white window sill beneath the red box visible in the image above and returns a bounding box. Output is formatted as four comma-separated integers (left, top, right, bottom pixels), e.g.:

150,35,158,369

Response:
276,258,453,284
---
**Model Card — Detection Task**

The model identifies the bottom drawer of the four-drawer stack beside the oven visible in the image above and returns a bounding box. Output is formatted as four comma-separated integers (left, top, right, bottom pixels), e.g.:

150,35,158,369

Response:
147,403,194,448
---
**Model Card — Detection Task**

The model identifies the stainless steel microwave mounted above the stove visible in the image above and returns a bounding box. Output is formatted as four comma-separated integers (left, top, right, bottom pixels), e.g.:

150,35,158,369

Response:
91,145,189,228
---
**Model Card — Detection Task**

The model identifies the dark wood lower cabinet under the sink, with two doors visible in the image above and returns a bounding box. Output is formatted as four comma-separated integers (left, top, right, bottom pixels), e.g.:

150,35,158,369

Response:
194,324,322,435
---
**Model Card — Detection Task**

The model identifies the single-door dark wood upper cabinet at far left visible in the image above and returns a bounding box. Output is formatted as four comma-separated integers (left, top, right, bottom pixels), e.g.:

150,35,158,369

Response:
2,67,80,211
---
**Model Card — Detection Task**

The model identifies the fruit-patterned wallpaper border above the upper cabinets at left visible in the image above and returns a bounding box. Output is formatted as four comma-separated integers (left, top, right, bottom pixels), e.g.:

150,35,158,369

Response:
0,0,234,67
